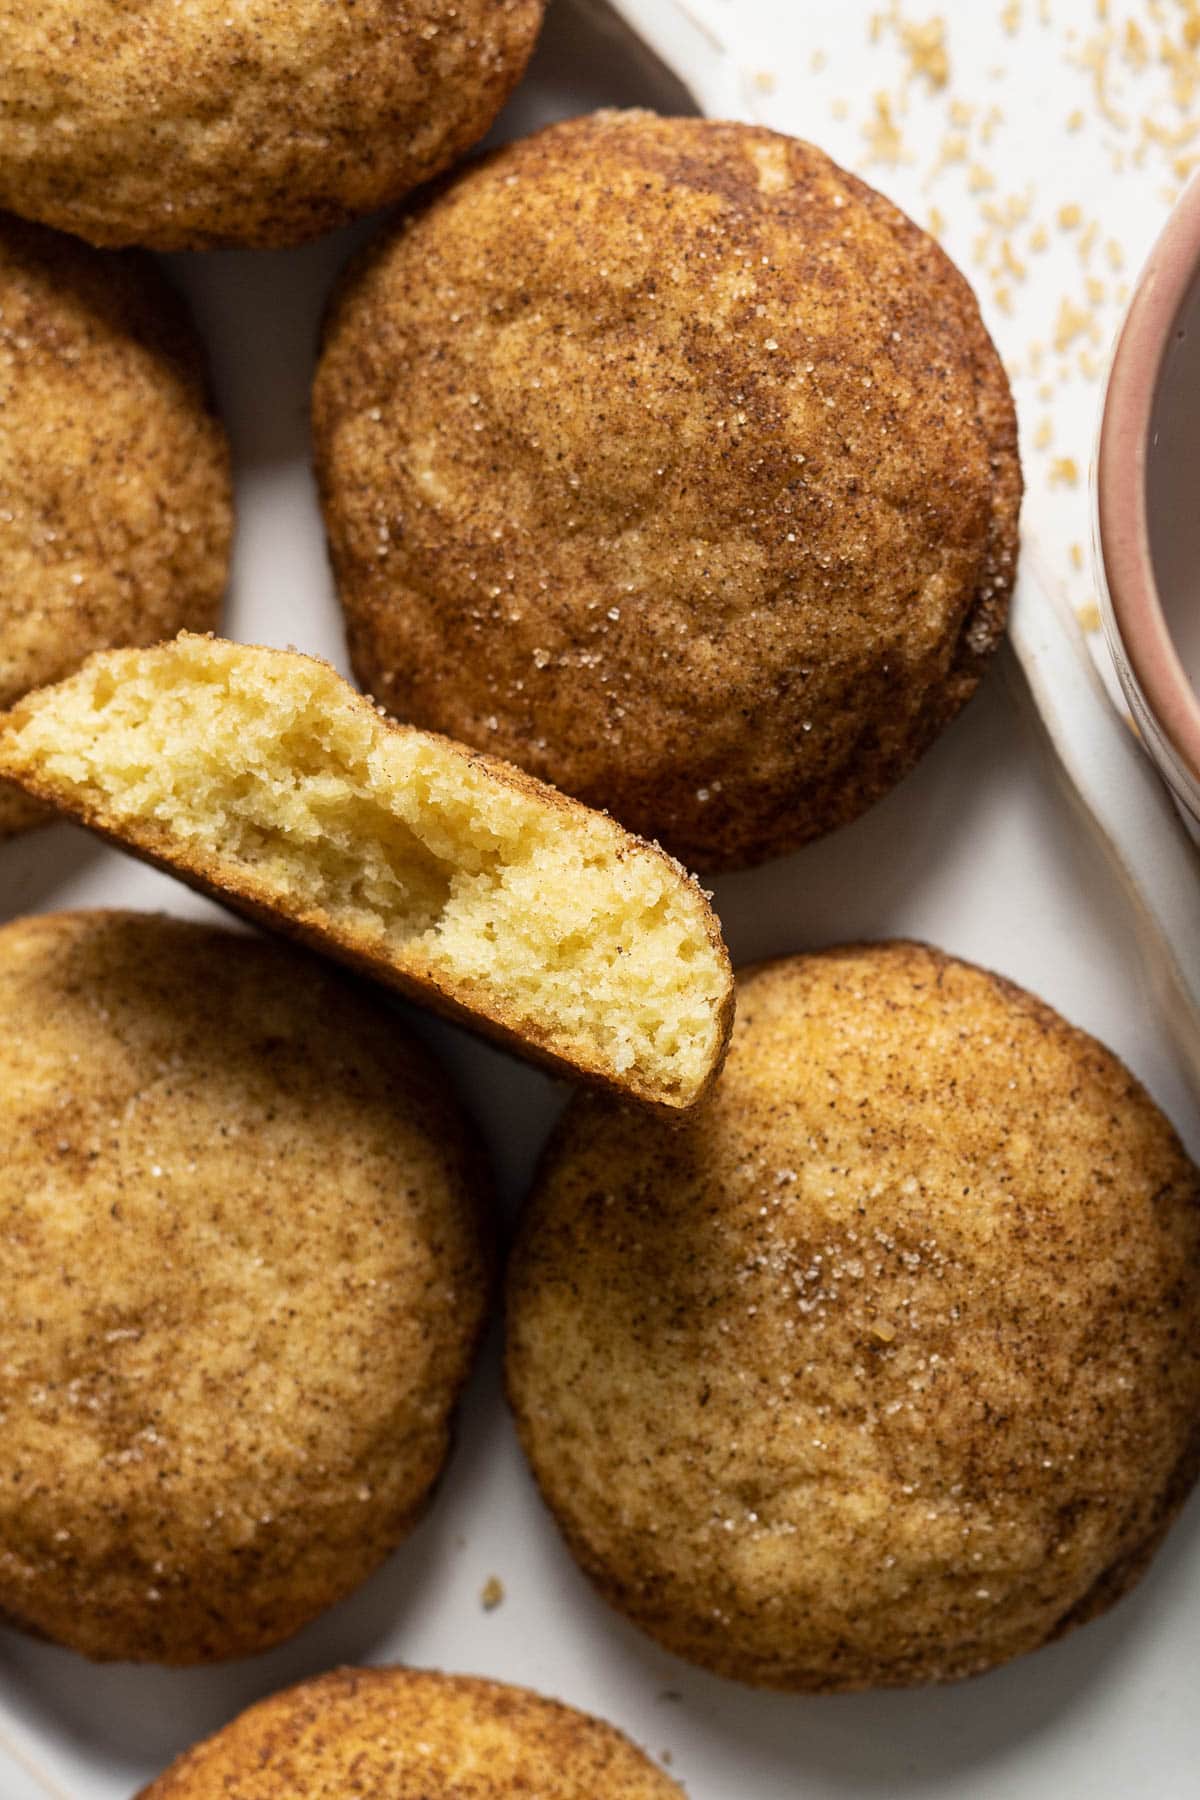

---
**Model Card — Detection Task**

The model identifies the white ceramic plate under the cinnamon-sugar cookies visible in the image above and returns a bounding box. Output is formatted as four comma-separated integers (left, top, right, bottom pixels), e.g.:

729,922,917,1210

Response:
0,0,1200,1800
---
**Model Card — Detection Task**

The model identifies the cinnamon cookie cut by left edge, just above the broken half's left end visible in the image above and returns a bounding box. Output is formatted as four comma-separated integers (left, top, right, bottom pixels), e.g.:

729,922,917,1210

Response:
0,216,232,837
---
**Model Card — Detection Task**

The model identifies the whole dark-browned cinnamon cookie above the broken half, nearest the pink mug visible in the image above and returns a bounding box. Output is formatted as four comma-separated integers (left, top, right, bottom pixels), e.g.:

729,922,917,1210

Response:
313,112,1020,869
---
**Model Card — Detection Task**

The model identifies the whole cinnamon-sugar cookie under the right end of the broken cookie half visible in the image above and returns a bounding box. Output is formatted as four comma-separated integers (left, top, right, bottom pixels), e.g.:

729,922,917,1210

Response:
507,943,1200,1690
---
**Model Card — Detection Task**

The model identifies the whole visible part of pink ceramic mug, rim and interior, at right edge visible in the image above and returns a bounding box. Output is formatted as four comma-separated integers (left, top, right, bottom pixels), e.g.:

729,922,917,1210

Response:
1094,178,1200,835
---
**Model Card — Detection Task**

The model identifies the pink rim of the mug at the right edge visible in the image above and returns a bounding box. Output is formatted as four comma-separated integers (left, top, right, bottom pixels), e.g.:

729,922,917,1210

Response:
1096,176,1200,781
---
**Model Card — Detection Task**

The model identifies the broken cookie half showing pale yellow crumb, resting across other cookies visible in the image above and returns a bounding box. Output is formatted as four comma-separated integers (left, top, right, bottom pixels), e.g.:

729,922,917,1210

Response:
0,637,734,1112
